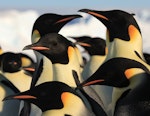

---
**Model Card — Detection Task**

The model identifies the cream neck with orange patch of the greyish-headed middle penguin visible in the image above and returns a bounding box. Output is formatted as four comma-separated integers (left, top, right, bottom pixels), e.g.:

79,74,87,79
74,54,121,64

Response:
52,47,82,87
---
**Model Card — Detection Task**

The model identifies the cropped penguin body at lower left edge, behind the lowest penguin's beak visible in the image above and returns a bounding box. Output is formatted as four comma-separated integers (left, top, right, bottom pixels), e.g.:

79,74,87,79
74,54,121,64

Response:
0,74,20,116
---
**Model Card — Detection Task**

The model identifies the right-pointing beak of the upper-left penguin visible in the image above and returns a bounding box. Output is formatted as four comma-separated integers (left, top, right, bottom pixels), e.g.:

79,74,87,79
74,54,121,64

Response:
55,15,82,24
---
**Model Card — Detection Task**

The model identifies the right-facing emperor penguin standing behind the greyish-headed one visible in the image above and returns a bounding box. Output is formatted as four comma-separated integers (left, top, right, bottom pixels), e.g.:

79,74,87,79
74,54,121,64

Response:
31,13,81,85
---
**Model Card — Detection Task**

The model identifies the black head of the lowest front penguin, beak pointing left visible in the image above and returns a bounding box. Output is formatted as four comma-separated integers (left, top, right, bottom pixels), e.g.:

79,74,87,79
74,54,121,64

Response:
4,81,76,112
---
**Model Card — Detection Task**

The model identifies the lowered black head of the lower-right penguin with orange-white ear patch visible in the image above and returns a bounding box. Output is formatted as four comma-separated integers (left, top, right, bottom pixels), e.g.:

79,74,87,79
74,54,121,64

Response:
79,57,150,87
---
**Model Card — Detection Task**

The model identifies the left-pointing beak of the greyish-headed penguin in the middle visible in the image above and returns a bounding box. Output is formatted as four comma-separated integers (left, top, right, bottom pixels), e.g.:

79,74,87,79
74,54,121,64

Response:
23,44,49,51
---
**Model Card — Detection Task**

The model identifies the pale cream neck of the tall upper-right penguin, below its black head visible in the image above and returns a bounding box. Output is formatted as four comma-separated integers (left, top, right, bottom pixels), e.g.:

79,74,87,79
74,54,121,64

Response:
107,38,144,59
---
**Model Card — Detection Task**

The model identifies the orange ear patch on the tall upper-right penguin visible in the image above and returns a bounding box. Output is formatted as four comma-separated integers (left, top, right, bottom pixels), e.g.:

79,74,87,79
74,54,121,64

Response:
128,25,142,41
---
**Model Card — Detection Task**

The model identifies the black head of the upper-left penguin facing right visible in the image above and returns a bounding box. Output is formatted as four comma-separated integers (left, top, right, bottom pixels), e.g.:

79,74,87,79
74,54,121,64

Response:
31,13,81,43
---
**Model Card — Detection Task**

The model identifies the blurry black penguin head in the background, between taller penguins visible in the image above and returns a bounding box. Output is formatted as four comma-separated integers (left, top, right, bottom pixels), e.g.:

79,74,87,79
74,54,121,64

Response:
71,36,106,55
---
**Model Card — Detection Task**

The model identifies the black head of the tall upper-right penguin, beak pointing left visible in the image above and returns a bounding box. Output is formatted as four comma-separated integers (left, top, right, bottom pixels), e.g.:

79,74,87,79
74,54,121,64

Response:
79,9,141,42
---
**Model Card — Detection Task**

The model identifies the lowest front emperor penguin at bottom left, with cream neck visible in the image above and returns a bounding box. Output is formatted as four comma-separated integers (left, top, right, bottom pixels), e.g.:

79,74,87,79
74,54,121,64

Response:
4,81,95,116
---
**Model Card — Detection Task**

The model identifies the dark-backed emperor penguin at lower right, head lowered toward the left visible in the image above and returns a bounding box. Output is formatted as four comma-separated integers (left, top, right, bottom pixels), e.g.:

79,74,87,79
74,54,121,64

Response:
80,57,150,116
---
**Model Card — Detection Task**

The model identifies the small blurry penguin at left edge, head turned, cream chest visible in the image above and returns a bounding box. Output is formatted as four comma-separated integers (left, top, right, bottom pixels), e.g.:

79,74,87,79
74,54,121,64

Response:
0,52,34,91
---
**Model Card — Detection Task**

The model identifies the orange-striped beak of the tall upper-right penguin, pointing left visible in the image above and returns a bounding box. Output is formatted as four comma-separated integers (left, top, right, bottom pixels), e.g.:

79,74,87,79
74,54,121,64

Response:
79,9,109,21
